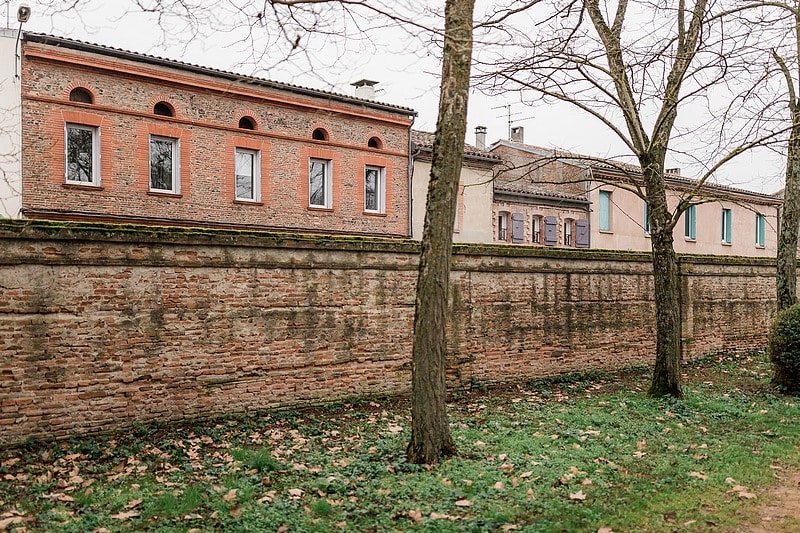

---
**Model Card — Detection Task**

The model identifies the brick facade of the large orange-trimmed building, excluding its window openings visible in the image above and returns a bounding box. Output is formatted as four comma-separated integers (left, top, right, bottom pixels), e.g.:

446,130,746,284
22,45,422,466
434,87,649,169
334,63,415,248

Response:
22,42,413,236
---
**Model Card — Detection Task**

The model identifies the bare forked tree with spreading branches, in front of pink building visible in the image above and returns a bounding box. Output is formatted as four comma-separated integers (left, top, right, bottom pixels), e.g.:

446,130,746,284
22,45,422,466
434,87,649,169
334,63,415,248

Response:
480,0,754,398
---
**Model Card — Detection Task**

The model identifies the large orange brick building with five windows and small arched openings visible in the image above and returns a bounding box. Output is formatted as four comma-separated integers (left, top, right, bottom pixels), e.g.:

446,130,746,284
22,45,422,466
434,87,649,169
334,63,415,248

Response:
11,33,415,237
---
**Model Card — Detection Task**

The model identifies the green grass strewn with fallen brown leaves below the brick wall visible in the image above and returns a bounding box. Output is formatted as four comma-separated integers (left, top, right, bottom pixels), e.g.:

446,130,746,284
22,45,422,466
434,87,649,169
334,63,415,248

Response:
0,355,800,532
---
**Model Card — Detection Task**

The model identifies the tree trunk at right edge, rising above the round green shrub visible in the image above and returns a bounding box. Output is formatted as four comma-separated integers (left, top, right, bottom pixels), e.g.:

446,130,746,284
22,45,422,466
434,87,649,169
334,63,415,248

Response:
776,114,800,311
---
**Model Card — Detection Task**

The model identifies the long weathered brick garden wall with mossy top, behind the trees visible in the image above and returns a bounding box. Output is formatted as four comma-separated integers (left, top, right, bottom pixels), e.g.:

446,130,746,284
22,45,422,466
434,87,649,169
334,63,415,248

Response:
0,221,774,445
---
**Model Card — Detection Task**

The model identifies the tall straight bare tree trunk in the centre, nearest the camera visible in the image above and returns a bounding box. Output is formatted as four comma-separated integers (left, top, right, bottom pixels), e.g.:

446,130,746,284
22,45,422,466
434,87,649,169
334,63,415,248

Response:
406,0,475,464
